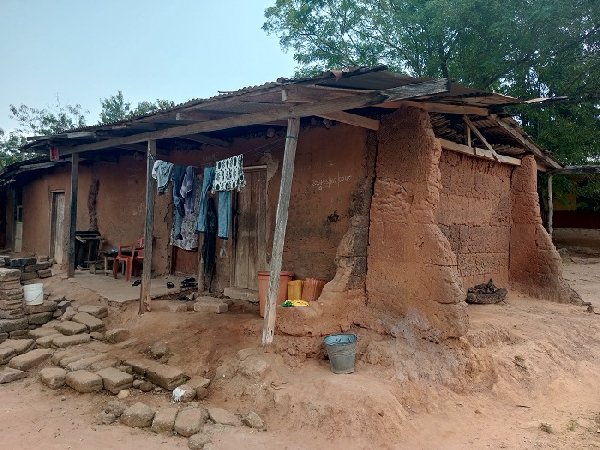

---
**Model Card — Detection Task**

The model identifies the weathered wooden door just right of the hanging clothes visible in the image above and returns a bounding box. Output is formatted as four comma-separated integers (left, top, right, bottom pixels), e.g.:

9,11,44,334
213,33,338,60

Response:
231,166,268,290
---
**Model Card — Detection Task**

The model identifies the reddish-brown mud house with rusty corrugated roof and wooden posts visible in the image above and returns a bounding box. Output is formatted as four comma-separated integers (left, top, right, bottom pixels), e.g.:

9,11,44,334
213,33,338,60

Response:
2,67,576,343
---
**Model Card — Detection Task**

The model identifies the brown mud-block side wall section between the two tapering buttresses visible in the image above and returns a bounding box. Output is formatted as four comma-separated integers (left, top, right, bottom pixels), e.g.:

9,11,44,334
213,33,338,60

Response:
436,150,513,288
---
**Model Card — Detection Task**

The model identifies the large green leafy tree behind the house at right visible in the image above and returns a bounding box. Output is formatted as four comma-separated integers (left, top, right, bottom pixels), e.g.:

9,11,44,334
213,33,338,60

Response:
263,0,600,164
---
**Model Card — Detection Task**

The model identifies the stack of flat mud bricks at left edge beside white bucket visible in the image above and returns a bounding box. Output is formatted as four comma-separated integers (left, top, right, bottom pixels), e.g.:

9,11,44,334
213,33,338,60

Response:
0,267,61,342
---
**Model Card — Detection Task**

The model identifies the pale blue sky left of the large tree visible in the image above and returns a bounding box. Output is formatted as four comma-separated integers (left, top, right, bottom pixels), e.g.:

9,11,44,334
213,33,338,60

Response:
0,0,296,131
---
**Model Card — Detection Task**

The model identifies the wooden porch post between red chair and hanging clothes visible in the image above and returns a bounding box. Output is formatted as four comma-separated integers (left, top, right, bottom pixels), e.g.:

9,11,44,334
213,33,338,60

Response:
139,140,156,314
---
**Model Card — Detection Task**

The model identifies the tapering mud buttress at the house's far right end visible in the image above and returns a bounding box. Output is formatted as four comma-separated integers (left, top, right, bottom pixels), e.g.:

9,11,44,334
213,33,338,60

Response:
509,155,581,304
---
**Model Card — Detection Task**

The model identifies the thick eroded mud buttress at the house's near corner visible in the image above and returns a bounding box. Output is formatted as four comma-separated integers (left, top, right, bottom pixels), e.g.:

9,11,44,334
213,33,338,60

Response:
366,108,468,341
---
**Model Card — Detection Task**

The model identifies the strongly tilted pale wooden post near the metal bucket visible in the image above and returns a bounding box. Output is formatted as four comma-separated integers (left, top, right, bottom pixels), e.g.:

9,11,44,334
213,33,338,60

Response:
263,118,300,345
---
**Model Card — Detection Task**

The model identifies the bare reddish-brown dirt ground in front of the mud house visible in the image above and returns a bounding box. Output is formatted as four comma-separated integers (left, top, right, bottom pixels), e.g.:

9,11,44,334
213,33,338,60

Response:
0,252,600,450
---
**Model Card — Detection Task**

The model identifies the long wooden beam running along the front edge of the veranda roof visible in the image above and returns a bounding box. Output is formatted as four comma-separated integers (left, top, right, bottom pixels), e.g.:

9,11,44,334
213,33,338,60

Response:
61,79,450,155
